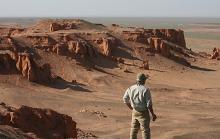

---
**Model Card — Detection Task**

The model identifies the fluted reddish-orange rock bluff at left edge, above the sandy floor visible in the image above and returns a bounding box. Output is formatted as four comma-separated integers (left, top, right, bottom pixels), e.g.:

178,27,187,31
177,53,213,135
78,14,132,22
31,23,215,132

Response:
0,50,51,83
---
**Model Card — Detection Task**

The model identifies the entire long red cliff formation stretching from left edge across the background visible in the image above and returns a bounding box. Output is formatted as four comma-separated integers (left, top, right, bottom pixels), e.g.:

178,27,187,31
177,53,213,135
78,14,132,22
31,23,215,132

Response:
0,20,196,83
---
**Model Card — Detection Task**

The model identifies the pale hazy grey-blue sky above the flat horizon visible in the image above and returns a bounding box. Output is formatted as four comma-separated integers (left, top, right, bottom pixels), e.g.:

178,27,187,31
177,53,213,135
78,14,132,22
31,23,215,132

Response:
0,0,220,17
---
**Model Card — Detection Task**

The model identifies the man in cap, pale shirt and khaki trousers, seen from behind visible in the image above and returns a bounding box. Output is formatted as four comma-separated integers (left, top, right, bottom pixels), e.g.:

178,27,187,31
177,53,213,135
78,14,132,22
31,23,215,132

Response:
123,73,157,139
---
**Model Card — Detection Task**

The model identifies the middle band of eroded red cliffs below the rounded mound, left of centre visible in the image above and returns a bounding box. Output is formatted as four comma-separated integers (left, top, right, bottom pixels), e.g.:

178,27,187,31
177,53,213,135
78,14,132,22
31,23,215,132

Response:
26,33,118,58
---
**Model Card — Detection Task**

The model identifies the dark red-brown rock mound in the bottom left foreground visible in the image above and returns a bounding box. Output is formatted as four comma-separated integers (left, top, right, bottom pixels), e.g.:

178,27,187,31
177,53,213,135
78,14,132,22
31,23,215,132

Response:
0,103,77,139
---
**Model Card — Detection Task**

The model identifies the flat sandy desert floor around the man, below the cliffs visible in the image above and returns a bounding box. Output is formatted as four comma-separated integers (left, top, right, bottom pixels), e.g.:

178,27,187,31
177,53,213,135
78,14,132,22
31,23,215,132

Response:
0,53,220,139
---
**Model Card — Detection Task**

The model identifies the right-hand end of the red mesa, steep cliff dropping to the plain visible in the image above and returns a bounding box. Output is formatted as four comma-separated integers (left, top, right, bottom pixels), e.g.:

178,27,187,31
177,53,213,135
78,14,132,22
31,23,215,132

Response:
113,26,190,66
